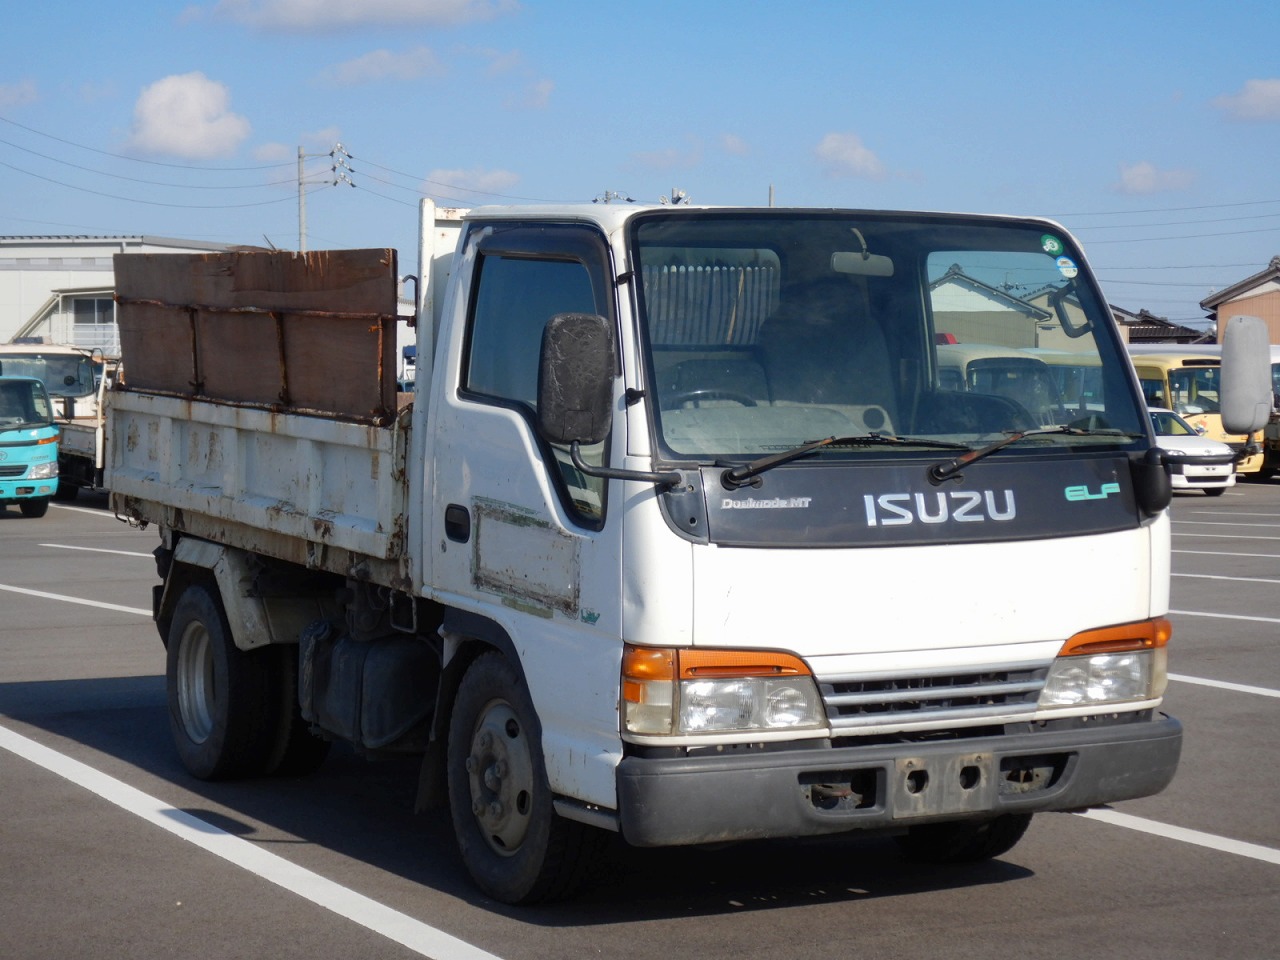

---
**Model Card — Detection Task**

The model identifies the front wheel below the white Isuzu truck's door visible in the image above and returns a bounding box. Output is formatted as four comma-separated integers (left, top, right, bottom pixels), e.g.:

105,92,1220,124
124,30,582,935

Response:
447,653,605,904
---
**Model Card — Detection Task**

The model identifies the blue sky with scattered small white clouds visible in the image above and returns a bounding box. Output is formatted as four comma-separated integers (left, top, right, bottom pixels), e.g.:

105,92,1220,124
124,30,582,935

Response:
0,0,1280,323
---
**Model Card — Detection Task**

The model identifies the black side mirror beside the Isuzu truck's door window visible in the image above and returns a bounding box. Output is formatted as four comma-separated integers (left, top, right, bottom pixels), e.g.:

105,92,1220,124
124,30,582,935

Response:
538,314,617,445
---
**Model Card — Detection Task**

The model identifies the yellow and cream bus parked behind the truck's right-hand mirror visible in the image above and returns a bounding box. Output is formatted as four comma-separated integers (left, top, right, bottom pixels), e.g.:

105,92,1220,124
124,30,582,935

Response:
1129,343,1262,477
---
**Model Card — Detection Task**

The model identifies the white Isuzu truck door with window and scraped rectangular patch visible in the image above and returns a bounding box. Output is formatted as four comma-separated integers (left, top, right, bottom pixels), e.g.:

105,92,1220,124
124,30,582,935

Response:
426,223,621,806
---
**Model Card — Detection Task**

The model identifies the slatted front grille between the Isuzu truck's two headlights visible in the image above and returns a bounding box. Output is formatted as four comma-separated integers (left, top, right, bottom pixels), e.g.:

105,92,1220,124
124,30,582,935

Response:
820,664,1048,736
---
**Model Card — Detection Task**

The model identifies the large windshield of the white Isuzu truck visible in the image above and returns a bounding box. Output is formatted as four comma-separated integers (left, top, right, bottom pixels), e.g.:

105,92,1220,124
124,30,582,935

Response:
632,211,1144,460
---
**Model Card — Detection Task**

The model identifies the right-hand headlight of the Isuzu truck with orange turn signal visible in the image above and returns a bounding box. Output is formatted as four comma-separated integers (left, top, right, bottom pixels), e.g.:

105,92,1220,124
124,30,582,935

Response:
1039,618,1172,708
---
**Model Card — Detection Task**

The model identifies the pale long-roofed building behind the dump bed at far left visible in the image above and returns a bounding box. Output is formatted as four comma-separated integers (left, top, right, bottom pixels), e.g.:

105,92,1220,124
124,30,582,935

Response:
0,236,229,356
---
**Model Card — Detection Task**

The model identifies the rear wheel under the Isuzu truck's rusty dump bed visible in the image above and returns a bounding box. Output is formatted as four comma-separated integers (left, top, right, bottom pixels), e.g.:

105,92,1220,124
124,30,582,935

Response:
165,582,279,780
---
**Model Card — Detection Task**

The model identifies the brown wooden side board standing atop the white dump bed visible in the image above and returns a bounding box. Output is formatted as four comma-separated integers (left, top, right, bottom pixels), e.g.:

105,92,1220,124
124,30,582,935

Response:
115,250,398,421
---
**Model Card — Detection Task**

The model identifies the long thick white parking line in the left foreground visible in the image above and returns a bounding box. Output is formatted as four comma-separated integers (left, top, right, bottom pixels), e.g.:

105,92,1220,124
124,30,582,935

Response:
0,726,498,960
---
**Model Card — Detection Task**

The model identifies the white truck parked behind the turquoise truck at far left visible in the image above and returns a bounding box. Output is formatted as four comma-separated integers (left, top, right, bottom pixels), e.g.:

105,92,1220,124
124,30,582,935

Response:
0,337,119,500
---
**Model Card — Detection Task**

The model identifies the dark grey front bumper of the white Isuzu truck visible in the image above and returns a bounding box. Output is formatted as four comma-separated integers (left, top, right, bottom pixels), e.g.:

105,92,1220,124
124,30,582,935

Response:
617,716,1183,846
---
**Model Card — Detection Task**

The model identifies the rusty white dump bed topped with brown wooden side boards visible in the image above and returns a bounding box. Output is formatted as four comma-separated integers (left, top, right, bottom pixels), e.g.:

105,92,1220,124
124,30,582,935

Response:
108,250,410,585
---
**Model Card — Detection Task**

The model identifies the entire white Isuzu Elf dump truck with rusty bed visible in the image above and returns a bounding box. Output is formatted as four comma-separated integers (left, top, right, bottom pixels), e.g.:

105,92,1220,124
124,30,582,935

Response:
108,202,1270,904
